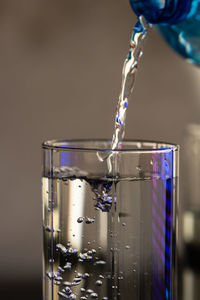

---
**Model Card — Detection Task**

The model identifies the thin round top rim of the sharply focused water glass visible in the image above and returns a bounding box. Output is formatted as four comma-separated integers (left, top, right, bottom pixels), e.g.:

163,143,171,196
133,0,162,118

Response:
42,139,180,153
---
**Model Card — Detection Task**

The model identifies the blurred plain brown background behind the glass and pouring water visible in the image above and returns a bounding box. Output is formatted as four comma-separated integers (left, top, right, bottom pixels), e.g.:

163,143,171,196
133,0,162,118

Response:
0,0,200,299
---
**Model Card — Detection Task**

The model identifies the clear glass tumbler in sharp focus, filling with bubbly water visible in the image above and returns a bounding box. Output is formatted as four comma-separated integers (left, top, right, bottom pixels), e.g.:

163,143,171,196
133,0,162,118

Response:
42,140,179,300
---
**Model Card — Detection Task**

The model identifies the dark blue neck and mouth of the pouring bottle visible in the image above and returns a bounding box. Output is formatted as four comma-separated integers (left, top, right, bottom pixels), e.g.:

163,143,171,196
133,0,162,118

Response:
130,0,192,24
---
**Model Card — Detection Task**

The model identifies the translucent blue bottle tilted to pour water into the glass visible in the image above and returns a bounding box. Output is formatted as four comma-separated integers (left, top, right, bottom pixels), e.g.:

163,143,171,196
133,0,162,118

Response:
130,0,200,65
